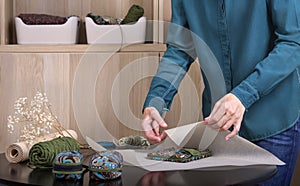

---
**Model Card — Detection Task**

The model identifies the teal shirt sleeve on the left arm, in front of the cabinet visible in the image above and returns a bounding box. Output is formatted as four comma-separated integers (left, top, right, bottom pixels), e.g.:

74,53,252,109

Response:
143,0,195,115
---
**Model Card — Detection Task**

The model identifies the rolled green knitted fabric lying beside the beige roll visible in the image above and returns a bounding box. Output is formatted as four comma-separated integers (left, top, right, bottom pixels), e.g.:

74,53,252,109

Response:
28,137,80,168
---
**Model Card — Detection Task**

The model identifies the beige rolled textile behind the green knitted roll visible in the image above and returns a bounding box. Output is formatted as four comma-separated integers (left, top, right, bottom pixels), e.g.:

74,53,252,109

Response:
5,130,78,163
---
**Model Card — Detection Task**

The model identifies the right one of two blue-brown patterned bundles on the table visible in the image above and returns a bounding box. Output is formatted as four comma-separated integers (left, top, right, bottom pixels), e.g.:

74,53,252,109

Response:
89,151,123,180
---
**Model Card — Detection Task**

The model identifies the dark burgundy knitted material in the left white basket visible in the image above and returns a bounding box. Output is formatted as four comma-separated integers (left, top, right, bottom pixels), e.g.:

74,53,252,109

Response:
18,14,68,25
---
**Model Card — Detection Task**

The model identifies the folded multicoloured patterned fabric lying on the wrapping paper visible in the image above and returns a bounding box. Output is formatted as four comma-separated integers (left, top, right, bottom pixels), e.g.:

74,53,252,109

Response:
147,148,211,163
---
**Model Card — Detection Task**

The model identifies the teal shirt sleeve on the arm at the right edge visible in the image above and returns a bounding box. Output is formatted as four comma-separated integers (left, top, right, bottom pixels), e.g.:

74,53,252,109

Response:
232,0,300,109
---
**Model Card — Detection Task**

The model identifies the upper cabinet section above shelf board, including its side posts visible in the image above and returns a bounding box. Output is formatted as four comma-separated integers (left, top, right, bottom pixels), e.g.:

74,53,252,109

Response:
0,0,171,45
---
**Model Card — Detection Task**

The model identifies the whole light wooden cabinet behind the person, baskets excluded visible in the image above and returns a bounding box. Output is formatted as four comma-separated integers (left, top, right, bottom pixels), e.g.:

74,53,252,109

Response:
0,0,202,152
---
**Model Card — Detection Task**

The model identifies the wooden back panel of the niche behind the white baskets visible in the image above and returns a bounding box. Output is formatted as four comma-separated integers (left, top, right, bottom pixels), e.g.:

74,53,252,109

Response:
6,0,153,44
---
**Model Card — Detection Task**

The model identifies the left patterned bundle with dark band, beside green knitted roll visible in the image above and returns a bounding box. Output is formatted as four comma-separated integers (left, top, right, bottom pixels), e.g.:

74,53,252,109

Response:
52,151,84,180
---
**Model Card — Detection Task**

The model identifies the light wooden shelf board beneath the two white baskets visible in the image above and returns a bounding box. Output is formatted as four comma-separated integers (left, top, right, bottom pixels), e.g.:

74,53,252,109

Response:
0,44,166,53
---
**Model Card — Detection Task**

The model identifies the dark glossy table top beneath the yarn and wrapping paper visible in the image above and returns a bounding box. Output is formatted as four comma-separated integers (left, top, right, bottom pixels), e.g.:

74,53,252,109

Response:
0,153,277,186
